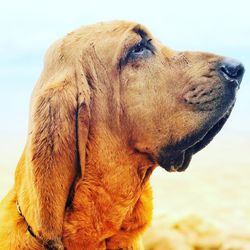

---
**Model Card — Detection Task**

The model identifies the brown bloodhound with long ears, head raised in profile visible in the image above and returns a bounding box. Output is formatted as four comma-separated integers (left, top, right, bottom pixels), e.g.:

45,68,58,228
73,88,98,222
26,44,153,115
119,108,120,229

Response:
0,21,244,250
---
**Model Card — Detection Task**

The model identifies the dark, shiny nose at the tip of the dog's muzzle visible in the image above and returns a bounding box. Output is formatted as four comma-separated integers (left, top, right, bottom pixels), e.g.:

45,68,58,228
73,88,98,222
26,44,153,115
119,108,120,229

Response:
219,58,245,86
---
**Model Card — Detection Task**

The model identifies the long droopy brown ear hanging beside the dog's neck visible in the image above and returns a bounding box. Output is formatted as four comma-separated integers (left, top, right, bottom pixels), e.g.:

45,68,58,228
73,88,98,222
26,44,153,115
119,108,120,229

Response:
17,40,90,249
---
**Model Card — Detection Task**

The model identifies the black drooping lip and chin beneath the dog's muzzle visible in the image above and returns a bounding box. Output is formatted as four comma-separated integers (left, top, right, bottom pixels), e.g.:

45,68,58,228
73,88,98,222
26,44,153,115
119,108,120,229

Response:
157,107,232,172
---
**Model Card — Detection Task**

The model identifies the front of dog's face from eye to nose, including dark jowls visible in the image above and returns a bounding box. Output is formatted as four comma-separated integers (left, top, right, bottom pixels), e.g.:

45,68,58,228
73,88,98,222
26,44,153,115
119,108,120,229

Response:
117,24,244,171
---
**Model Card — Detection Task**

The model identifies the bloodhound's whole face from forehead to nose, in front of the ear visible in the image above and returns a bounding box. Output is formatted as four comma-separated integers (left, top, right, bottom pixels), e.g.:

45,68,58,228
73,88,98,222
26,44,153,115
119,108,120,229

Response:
62,22,244,171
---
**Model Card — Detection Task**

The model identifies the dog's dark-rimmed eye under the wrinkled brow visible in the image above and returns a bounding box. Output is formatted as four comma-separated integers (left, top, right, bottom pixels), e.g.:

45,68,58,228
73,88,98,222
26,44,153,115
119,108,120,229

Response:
128,39,153,60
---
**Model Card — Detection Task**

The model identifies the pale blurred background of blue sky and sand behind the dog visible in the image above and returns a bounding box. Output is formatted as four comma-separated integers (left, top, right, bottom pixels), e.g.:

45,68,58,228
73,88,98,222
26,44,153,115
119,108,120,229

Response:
0,0,250,250
